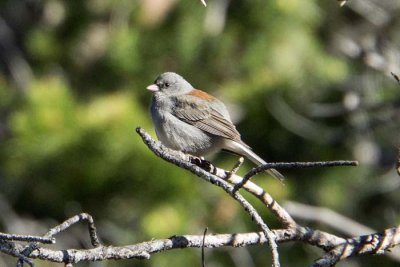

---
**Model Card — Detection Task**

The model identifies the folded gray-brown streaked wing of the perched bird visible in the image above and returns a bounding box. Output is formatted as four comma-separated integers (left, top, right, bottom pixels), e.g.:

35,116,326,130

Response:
173,96,242,142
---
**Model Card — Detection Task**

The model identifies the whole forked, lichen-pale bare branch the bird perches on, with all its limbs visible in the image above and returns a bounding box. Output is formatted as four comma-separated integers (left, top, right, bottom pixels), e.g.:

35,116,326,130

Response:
0,128,400,266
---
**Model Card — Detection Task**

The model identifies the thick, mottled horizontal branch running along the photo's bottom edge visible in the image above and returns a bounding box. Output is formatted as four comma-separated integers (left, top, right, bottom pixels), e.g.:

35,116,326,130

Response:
0,226,400,266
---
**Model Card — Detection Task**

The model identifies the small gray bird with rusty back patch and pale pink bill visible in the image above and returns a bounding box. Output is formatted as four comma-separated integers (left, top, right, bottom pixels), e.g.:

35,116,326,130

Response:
147,72,283,180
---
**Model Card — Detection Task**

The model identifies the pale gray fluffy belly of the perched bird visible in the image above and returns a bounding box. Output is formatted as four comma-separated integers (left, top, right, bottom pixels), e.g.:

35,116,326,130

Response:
153,114,222,156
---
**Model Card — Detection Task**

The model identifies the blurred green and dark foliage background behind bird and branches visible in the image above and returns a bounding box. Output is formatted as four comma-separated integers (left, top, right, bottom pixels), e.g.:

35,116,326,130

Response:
0,0,400,267
